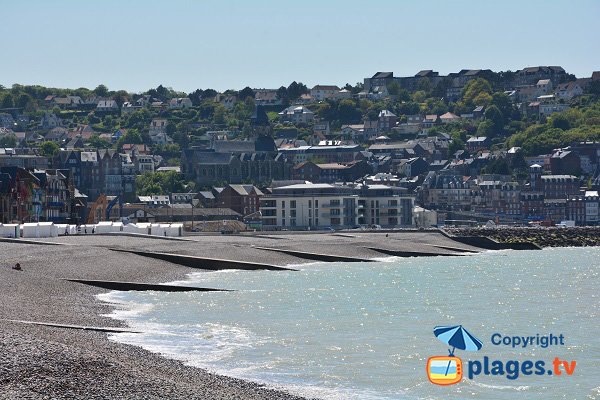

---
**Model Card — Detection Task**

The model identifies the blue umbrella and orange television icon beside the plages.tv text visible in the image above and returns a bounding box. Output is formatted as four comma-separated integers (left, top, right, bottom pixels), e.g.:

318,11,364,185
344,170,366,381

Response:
427,325,483,385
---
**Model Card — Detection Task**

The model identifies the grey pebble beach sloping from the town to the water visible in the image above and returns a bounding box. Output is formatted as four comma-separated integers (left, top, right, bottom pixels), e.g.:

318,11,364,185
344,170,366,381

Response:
0,231,580,399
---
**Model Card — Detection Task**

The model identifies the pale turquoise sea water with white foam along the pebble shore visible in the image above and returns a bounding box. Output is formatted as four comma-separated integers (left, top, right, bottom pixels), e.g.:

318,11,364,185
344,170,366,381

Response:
100,248,600,399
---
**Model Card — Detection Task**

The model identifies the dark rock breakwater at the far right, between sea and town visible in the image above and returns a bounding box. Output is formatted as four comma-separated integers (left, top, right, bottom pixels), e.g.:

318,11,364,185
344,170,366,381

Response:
444,227,600,250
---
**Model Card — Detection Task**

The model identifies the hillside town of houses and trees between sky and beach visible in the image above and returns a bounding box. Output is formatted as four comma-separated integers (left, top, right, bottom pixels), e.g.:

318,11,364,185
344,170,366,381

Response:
0,66,600,230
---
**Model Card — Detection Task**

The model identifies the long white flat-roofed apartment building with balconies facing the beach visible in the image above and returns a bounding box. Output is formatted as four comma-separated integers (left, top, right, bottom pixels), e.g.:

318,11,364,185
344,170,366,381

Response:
260,182,414,230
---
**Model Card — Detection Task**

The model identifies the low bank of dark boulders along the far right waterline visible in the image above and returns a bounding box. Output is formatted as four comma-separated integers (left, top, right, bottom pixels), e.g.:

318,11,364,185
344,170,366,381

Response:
445,227,600,247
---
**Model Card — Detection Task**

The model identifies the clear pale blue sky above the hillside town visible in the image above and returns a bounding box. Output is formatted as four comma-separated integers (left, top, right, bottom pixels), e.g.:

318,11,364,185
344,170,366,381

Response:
0,0,600,92
